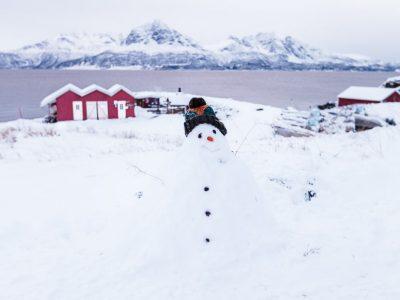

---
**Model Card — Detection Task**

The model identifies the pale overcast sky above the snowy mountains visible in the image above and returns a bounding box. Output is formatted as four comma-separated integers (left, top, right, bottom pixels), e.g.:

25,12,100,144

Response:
0,0,400,61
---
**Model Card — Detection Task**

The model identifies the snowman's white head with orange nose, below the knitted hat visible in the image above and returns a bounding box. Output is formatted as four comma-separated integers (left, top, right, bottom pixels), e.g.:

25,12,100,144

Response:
187,124,229,152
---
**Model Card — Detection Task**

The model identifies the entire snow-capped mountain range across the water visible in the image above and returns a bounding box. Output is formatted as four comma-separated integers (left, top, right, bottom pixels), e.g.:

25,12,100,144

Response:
0,21,399,71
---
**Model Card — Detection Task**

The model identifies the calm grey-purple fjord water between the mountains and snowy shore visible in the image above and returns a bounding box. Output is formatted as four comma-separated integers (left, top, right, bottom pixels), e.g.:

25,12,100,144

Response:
0,70,396,121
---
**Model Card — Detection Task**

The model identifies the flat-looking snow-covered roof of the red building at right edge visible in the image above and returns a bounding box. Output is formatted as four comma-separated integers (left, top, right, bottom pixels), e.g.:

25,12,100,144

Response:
338,86,397,102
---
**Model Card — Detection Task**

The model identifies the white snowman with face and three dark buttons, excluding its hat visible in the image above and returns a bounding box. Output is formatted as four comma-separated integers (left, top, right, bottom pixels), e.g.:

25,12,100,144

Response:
158,124,271,261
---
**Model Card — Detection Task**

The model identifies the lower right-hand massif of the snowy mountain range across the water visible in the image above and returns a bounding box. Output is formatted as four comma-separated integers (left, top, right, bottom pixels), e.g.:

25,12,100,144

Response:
219,33,383,69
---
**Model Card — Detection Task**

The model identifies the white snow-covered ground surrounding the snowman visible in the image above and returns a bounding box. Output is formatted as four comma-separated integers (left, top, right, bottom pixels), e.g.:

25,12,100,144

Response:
0,98,400,300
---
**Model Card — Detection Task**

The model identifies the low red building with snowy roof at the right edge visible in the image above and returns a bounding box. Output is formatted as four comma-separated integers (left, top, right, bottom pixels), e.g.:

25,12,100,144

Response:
338,86,400,106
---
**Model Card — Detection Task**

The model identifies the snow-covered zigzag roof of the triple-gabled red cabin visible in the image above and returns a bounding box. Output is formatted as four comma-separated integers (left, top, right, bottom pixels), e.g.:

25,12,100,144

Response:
40,83,134,107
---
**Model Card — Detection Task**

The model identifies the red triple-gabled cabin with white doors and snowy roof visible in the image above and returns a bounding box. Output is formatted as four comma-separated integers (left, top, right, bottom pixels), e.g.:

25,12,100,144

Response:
40,84,135,121
